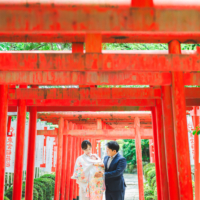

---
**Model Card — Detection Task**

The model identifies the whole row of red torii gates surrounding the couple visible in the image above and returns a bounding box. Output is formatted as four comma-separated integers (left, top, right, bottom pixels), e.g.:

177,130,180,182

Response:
0,0,200,200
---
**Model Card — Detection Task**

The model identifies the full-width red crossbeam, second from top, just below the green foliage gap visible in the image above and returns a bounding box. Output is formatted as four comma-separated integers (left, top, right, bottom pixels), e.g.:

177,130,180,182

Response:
0,52,200,72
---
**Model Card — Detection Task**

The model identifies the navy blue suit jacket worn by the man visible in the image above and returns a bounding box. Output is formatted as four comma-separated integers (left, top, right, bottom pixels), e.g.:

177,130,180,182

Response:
104,153,126,192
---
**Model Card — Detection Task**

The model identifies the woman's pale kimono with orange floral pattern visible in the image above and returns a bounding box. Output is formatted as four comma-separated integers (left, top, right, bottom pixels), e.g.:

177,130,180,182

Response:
71,154,105,200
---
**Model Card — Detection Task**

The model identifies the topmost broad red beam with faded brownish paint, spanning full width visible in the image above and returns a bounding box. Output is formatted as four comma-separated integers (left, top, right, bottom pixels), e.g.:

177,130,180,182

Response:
0,3,200,42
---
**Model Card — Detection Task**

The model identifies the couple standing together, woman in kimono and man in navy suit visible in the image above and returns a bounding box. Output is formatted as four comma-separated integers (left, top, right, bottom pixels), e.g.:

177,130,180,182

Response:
72,140,126,200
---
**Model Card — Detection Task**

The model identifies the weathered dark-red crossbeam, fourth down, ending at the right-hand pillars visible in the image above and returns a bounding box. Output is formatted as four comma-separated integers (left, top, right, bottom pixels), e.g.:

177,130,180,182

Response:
9,87,161,100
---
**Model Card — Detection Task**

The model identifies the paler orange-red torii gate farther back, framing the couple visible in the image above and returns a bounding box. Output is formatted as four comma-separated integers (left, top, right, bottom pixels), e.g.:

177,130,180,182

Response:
37,112,153,200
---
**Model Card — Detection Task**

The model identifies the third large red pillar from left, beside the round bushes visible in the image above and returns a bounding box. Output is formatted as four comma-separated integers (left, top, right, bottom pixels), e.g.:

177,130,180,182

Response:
25,107,37,200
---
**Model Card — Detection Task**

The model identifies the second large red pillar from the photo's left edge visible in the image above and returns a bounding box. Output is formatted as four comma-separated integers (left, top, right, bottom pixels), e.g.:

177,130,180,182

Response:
13,86,26,200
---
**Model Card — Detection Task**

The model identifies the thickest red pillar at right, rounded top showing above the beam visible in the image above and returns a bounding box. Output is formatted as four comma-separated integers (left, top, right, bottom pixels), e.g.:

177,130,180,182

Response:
169,41,193,200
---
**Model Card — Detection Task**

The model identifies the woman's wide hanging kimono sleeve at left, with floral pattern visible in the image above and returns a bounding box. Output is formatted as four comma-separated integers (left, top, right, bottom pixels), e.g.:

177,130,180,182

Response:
71,158,88,183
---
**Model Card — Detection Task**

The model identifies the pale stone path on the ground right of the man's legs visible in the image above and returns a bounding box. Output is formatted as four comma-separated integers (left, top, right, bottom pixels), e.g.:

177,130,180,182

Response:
103,173,139,200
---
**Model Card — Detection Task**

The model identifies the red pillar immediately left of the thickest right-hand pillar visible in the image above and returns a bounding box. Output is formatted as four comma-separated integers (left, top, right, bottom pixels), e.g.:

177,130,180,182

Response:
162,86,179,200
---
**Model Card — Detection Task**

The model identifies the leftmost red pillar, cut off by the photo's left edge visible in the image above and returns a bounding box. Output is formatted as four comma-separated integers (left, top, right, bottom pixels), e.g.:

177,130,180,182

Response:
0,85,8,200
